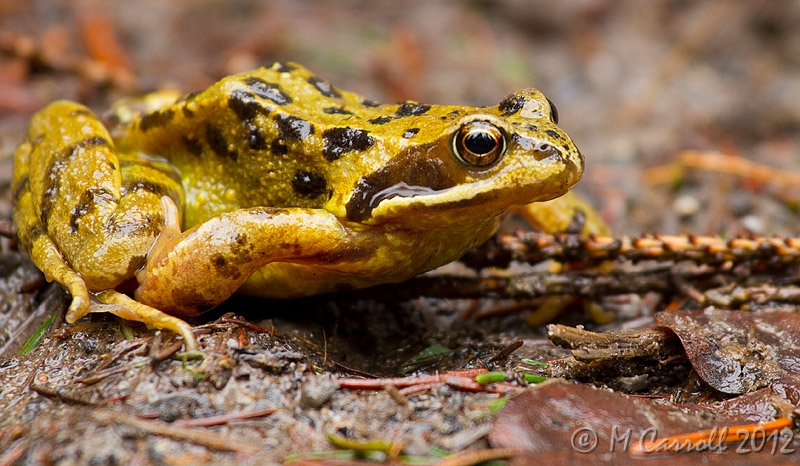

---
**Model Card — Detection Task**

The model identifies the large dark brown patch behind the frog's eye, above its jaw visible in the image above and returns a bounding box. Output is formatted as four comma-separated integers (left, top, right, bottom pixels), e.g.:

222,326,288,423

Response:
345,143,466,222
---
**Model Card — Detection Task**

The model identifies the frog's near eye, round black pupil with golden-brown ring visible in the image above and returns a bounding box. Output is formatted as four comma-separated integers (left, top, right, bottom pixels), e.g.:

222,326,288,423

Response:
453,121,506,168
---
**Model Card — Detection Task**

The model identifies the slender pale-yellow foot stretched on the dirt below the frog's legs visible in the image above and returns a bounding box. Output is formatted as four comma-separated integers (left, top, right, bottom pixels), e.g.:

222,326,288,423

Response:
88,290,199,351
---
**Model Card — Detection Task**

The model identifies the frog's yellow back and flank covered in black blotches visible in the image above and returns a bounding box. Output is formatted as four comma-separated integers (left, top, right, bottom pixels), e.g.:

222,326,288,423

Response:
113,63,459,227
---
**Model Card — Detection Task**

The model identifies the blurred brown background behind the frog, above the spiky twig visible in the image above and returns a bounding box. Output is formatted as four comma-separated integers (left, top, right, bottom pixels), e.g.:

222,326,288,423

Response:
0,0,800,234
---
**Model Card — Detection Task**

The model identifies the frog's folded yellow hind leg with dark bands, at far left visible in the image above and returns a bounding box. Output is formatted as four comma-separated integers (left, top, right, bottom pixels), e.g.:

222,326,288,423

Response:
12,101,196,349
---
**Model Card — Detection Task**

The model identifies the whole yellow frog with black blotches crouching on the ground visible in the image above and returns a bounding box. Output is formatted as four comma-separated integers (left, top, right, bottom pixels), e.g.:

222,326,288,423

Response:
11,62,585,351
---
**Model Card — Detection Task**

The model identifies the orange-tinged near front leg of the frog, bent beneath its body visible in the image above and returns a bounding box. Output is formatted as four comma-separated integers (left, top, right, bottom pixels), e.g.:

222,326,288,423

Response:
135,207,352,316
